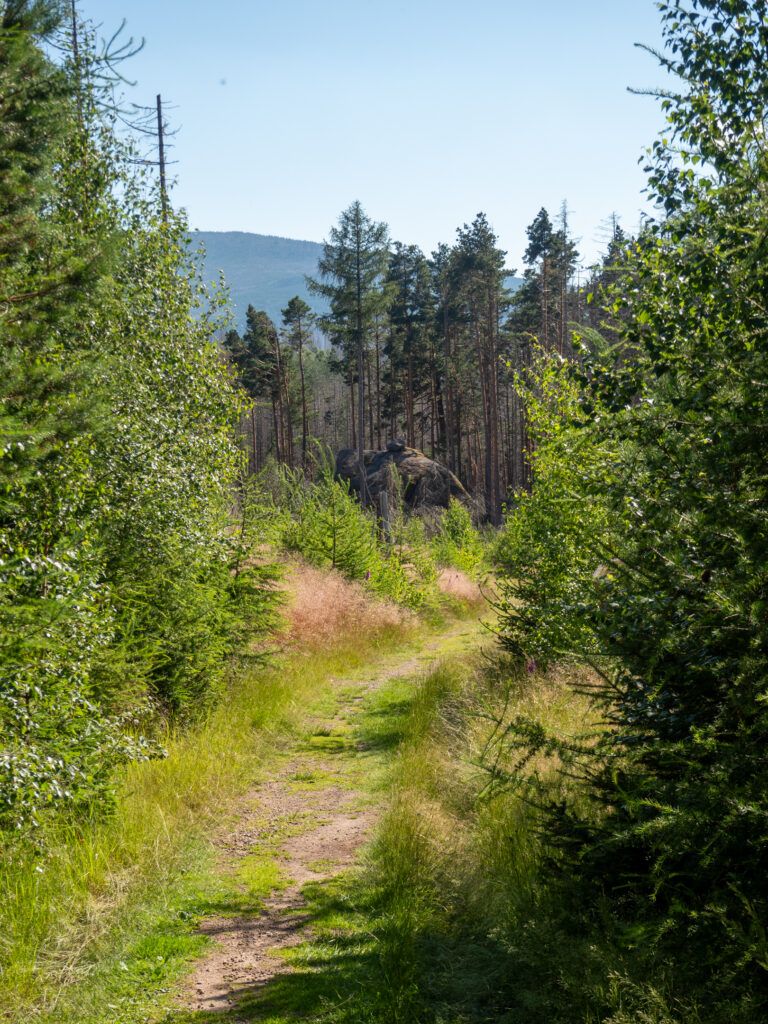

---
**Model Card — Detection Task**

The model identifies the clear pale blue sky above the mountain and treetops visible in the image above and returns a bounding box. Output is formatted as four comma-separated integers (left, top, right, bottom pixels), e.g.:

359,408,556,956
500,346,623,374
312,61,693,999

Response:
80,0,662,269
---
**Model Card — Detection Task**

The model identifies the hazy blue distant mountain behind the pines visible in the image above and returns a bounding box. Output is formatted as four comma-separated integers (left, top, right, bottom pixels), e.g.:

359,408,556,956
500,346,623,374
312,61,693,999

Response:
193,231,522,330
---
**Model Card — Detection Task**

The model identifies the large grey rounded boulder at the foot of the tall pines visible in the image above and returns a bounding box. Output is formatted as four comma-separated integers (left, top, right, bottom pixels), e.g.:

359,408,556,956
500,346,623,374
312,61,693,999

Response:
336,441,469,509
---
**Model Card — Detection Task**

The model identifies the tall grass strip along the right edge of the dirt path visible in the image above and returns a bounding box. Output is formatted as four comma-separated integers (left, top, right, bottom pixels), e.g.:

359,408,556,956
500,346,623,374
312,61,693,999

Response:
368,662,618,1024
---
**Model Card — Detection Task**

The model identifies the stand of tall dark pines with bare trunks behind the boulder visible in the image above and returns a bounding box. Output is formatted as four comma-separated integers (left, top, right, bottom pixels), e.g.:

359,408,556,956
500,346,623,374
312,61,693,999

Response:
224,203,627,522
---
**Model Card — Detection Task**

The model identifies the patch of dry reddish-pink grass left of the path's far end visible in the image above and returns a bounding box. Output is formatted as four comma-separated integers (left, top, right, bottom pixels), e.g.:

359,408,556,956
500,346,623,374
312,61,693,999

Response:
279,561,418,650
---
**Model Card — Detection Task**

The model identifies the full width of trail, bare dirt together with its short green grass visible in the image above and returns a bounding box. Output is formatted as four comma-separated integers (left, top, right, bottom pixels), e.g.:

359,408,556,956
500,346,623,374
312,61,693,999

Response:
153,621,489,1024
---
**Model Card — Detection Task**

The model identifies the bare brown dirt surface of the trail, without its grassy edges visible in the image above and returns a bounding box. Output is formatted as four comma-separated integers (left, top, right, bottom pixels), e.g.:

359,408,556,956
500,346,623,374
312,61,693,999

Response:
183,623,477,1014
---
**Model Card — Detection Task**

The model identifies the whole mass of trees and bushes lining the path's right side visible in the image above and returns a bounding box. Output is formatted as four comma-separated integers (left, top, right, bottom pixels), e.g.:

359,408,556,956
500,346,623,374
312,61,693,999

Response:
501,0,768,1011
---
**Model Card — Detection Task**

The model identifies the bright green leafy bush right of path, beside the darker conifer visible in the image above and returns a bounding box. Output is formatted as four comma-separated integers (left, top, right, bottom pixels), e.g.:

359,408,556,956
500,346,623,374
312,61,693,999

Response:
494,353,617,665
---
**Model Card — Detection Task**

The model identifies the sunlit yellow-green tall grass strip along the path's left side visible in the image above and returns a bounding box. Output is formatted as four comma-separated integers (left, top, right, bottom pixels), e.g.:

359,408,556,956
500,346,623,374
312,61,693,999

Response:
0,593,428,1022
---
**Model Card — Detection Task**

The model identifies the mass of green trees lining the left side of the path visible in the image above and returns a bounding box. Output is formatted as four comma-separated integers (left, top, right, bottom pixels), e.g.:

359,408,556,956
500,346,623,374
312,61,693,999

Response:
0,0,270,839
